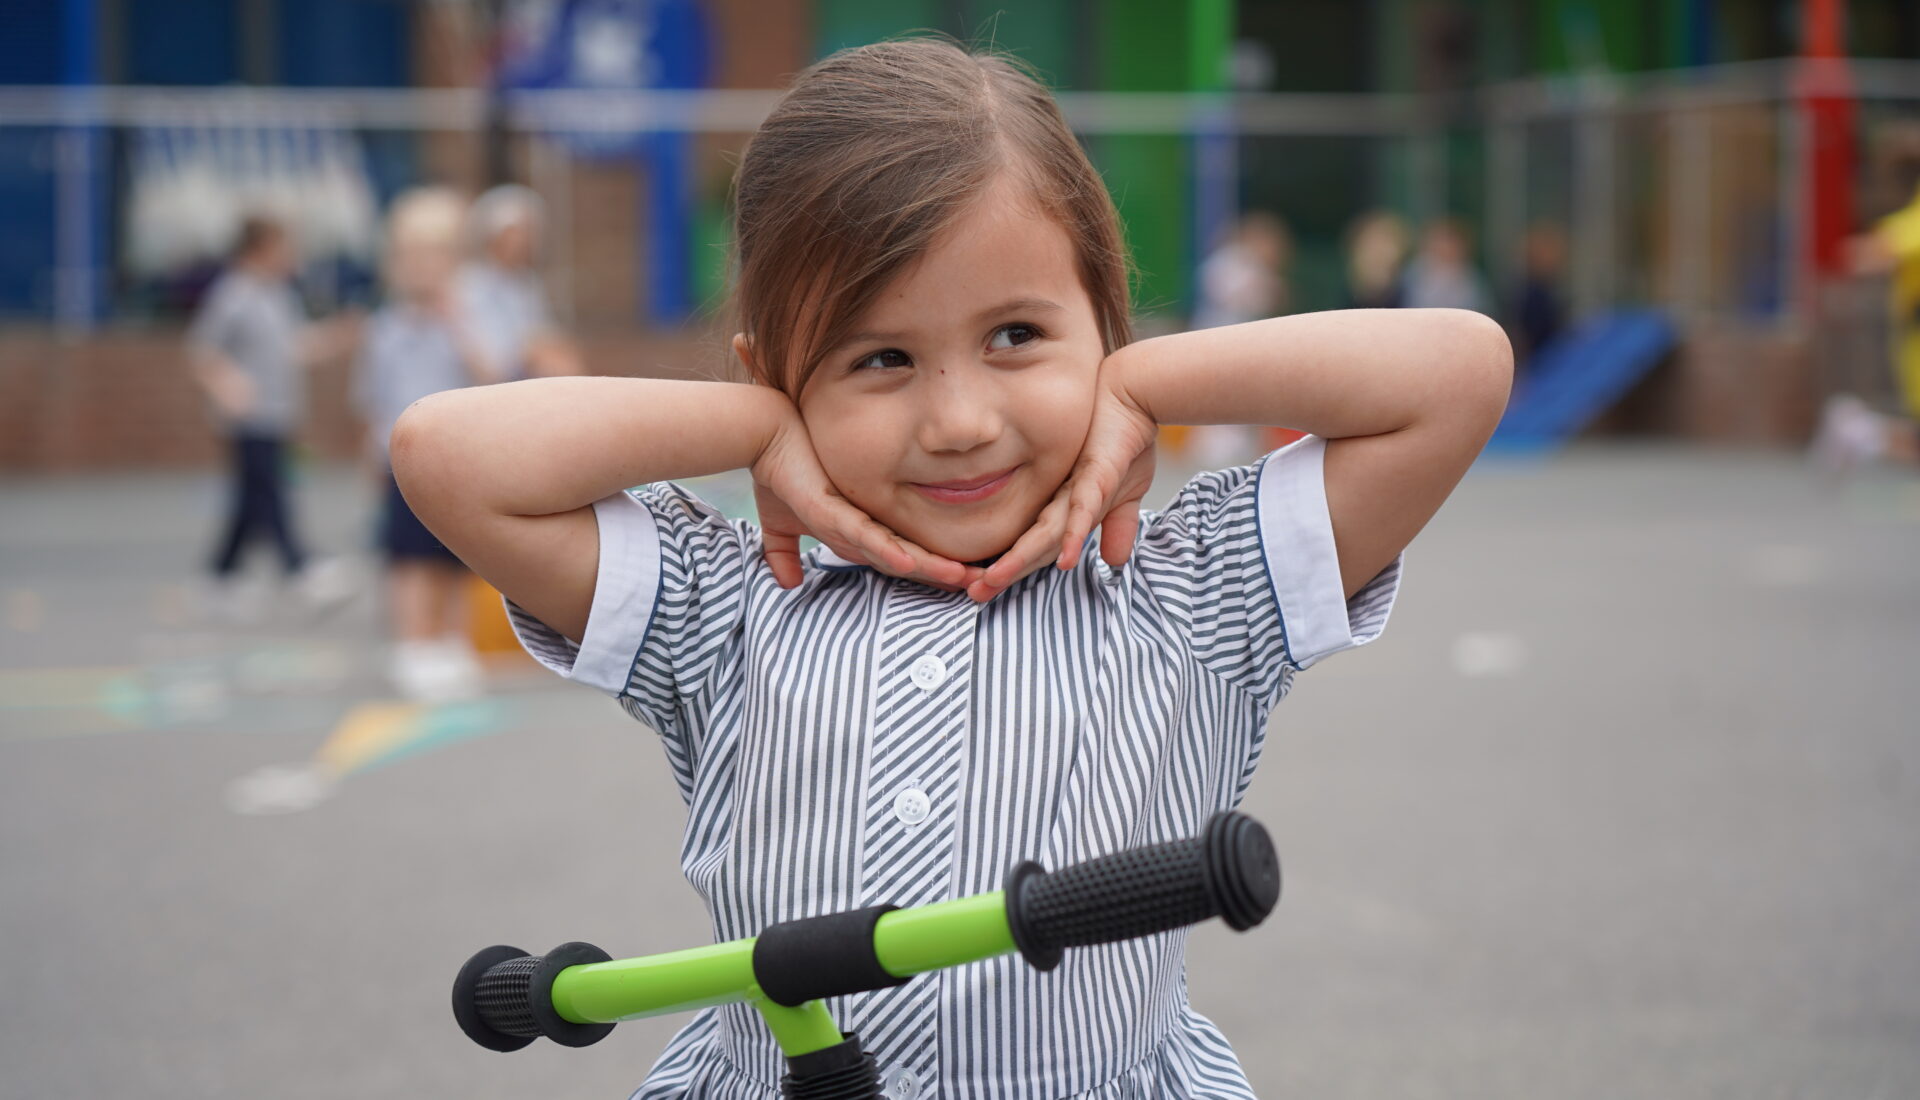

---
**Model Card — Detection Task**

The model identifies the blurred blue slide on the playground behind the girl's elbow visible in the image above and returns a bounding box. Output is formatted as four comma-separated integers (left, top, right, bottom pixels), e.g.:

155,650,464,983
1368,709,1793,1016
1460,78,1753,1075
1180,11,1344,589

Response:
1488,309,1678,453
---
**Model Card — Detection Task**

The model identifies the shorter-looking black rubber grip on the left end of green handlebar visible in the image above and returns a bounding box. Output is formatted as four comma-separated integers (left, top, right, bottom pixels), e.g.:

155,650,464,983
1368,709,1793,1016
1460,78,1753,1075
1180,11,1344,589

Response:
453,943,612,1052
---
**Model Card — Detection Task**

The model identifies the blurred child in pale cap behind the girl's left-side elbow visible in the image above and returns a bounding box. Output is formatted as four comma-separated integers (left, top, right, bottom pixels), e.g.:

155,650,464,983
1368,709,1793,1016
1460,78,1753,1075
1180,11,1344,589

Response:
457,184,582,380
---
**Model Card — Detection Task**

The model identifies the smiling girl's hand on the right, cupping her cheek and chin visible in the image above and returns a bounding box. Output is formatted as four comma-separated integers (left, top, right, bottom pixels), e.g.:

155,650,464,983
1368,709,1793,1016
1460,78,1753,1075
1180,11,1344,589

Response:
968,367,1160,603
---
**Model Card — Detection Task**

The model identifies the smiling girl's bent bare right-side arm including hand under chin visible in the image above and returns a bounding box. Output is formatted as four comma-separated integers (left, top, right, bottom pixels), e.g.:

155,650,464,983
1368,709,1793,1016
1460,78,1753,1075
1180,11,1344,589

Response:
975,309,1513,599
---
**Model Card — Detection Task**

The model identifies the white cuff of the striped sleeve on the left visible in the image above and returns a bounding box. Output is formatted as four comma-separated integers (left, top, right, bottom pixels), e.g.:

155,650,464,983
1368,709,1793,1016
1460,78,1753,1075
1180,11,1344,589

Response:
507,493,660,695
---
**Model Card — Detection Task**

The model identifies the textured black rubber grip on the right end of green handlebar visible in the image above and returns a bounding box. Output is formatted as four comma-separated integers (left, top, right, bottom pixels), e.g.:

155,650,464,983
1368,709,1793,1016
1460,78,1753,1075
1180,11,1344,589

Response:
1004,814,1281,969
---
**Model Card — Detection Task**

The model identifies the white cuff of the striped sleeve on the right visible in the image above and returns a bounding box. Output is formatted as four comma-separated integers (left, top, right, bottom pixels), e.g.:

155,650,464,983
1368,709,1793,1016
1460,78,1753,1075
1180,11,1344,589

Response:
1256,436,1400,668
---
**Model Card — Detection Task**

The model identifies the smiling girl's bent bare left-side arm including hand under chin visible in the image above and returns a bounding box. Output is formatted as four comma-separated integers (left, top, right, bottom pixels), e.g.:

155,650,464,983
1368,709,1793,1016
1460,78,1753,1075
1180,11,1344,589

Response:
390,378,962,641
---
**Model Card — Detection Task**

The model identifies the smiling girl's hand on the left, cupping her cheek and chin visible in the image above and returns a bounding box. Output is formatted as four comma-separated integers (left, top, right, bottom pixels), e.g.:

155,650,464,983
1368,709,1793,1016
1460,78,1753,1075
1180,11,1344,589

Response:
753,415,979,589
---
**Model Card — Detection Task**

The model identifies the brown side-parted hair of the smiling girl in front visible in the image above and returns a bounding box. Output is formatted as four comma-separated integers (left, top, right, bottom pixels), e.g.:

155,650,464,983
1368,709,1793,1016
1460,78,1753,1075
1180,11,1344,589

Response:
733,38,1133,395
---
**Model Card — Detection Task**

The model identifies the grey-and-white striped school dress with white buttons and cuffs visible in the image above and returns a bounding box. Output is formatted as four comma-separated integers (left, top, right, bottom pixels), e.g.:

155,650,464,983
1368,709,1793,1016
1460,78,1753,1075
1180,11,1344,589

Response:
509,438,1400,1100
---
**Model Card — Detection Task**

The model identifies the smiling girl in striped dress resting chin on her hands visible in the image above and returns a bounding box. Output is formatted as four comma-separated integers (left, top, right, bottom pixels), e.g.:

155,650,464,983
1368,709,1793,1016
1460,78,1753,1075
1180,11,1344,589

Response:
394,40,1509,1098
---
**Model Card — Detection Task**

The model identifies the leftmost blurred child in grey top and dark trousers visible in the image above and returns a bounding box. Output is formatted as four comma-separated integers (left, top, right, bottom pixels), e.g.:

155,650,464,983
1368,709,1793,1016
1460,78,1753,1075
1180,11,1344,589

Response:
188,215,357,618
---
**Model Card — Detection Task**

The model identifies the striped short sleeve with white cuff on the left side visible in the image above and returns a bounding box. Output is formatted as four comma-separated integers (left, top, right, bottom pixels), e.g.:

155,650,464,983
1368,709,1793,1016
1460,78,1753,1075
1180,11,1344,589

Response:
507,482,760,733
